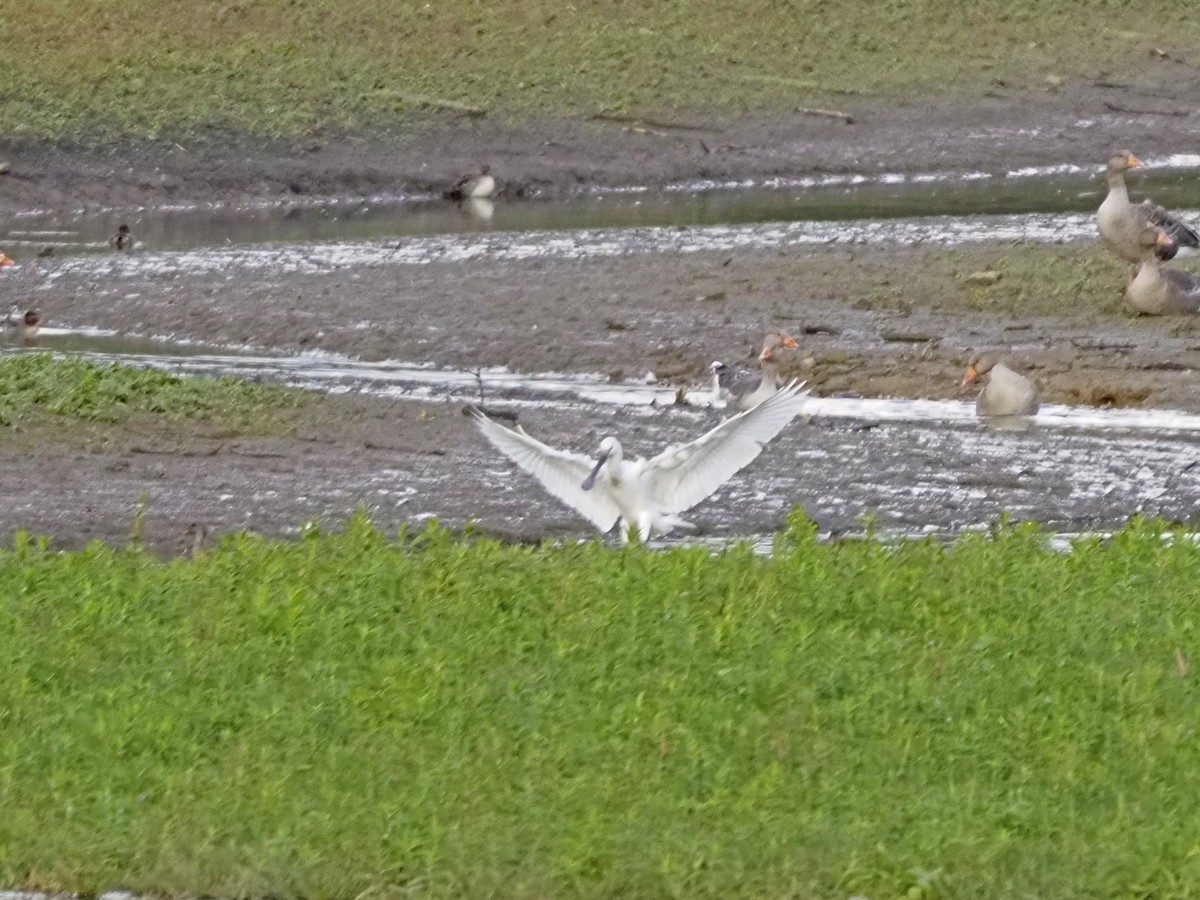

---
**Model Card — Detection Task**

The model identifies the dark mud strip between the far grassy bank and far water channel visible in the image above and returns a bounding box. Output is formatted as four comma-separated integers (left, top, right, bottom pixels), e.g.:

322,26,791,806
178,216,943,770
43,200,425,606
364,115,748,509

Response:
7,79,1200,215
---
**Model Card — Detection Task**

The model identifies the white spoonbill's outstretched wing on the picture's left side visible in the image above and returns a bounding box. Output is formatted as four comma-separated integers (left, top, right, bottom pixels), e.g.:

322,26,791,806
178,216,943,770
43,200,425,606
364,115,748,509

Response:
470,409,620,532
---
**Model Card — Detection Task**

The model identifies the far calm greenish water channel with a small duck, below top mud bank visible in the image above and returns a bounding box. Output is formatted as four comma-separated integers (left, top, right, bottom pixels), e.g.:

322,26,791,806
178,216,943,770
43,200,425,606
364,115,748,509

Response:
7,155,1200,262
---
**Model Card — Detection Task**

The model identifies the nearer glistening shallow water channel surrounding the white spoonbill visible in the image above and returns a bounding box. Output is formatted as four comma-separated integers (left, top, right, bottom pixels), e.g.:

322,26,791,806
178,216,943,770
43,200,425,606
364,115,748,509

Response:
10,330,1200,535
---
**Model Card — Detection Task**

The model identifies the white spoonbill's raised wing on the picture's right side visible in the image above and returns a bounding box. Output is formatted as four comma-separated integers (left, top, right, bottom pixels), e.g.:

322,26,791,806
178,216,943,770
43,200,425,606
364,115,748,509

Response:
646,382,809,512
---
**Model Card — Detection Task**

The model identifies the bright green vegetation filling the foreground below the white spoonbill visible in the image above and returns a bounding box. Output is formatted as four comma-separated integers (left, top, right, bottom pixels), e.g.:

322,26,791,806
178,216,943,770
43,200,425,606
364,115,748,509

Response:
0,511,1200,899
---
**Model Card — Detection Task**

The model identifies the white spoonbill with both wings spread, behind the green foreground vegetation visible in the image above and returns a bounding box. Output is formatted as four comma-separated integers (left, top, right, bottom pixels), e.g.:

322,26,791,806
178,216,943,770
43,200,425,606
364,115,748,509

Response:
470,382,809,542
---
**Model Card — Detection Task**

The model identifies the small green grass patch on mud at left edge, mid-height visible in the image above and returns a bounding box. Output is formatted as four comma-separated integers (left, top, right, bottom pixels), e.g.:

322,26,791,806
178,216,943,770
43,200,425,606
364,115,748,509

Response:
0,353,310,431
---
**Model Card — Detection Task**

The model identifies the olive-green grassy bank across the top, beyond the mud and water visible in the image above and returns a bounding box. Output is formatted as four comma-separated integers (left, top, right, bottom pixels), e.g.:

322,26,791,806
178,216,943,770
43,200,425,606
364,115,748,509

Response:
7,0,1200,137
